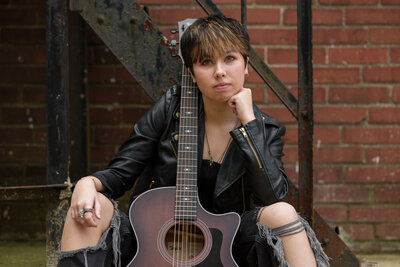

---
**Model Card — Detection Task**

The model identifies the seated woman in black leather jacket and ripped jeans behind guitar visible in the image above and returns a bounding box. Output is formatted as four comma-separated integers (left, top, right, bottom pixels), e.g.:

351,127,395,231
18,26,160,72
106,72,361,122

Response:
59,16,329,267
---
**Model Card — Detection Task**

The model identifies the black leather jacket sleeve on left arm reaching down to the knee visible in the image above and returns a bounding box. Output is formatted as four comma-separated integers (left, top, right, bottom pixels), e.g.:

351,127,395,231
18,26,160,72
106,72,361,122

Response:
92,90,171,198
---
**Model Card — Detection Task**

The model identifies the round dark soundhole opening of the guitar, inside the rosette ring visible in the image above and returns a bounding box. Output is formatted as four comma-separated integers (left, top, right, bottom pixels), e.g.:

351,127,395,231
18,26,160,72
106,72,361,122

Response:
165,222,204,261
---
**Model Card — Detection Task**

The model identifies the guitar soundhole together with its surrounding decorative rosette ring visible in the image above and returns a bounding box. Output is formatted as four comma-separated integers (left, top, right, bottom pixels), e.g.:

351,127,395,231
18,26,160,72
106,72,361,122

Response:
159,220,212,266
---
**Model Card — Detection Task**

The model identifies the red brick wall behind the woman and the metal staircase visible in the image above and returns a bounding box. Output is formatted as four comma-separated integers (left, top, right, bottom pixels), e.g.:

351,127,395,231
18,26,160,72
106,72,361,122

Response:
0,0,400,252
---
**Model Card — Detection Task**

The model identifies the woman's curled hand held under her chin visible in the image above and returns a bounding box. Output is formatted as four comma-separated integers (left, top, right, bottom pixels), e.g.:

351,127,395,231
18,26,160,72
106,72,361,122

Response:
228,88,256,125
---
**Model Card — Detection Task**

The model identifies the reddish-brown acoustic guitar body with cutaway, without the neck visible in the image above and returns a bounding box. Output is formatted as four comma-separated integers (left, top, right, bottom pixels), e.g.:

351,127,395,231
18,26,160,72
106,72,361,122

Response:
128,187,240,267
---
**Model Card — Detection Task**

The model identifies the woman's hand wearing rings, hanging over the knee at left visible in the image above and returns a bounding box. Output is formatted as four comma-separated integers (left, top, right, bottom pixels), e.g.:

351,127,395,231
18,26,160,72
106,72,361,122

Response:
70,176,101,227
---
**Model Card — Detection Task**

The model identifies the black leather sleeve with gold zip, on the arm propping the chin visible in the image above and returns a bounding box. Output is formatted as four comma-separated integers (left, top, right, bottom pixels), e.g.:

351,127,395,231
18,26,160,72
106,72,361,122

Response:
231,114,288,206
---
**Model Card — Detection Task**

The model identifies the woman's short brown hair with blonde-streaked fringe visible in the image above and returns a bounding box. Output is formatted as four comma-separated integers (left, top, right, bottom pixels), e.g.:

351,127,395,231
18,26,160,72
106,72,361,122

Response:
180,15,250,73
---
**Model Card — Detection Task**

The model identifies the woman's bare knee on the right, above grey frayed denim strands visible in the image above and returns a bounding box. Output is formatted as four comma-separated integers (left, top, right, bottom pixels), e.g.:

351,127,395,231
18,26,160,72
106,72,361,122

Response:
259,202,299,228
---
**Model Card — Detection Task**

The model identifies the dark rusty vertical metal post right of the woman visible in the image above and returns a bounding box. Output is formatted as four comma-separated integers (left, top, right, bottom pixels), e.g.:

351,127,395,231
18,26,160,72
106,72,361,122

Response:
297,0,314,225
